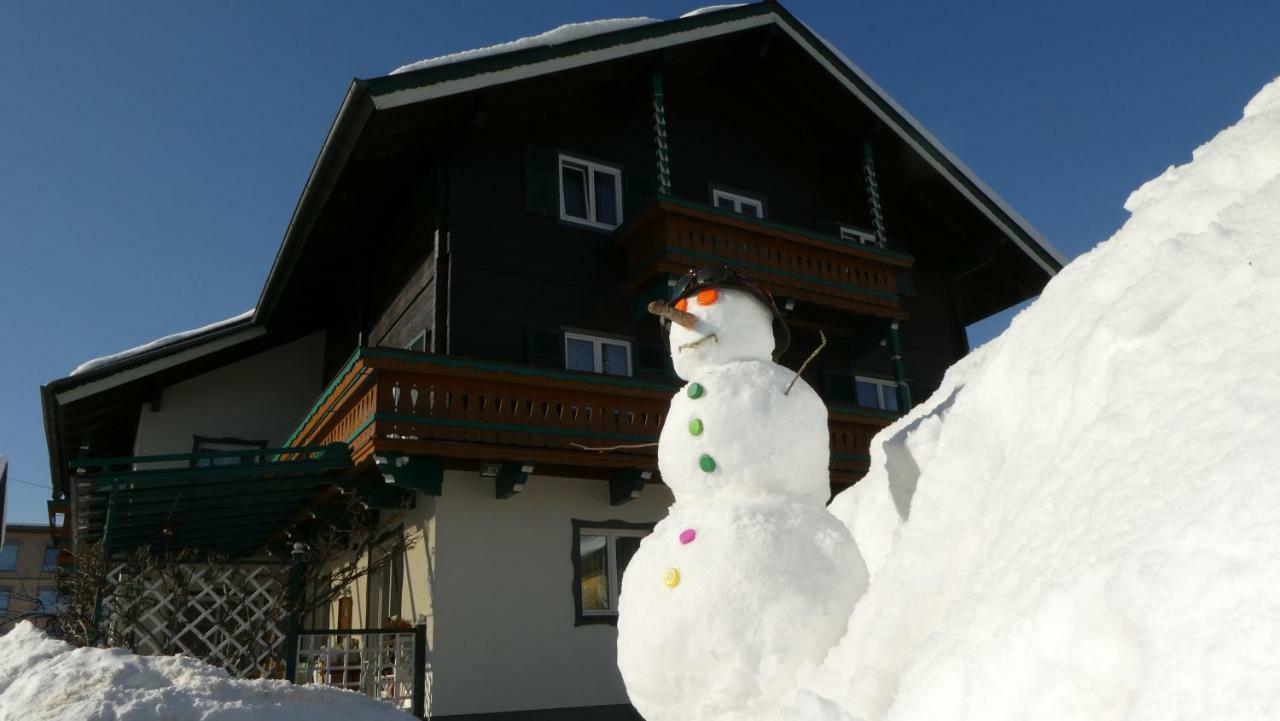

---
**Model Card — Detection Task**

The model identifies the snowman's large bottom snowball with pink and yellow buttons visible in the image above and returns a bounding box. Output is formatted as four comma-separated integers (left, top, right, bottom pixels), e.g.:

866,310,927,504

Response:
618,501,867,721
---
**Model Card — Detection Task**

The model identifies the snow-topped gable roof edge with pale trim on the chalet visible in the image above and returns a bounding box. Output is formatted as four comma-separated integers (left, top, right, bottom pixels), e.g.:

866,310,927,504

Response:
255,0,1066,323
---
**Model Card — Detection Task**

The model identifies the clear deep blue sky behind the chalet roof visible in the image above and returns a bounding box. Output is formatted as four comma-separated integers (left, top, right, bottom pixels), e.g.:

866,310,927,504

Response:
0,0,1280,520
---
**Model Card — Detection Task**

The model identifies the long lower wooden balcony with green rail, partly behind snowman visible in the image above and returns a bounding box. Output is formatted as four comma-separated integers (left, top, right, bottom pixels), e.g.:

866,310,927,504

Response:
288,348,892,484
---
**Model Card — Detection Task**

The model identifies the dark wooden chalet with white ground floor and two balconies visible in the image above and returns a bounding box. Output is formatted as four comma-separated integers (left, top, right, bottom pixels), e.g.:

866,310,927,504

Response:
42,1,1062,720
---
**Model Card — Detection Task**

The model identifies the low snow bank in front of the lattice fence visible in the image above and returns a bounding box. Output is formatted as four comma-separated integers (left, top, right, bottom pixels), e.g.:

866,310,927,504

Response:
0,621,413,721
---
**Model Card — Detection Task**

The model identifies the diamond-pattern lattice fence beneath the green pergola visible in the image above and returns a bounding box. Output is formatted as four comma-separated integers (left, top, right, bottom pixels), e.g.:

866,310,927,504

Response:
102,563,288,677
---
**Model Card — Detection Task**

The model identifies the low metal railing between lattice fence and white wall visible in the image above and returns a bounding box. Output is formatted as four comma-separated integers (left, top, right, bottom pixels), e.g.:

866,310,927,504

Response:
293,624,426,718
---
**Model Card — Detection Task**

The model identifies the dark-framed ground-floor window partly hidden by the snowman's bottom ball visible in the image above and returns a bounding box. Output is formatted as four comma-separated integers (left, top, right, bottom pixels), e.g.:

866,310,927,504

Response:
573,520,653,625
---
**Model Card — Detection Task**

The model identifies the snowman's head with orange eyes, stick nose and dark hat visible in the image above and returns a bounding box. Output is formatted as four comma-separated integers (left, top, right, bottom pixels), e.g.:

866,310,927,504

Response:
666,268,790,380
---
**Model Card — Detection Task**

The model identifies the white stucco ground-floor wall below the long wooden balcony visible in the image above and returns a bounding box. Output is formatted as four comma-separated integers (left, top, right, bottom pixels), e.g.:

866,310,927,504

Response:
430,471,672,716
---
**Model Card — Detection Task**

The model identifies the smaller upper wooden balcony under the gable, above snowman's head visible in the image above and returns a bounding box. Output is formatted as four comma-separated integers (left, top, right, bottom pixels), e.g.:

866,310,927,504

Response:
618,197,913,319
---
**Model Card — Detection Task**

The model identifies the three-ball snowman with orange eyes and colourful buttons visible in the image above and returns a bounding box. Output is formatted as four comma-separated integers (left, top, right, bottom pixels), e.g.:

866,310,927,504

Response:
618,266,867,721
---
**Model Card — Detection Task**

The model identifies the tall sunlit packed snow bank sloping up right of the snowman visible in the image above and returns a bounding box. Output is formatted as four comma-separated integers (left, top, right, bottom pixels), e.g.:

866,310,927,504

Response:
810,74,1280,721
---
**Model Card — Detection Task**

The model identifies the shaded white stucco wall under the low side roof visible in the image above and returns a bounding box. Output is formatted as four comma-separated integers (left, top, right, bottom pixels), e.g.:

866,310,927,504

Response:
133,333,324,456
